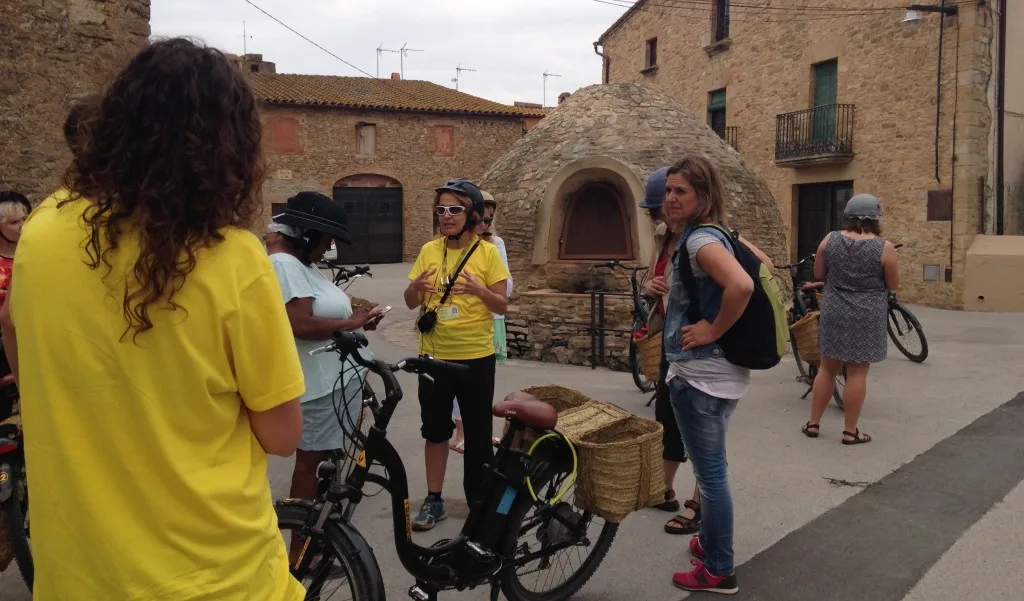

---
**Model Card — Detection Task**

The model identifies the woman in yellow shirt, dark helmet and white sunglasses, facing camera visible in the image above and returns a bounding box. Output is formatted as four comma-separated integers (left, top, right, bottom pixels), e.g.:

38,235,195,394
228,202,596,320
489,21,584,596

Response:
406,179,509,530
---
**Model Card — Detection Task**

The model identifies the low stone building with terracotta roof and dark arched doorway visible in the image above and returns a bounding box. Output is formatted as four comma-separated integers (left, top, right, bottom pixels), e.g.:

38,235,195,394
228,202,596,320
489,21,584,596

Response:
243,67,546,263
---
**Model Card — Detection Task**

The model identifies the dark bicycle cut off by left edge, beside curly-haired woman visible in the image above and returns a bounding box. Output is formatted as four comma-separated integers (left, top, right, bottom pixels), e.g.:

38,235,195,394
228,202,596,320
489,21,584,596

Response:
0,342,35,591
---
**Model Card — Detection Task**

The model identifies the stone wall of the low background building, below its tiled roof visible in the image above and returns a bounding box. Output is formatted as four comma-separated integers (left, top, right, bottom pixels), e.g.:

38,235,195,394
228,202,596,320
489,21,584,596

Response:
256,104,523,260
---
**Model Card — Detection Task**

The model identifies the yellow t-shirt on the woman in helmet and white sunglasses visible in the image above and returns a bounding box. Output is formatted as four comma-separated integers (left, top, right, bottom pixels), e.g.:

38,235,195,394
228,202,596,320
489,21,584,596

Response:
409,238,509,359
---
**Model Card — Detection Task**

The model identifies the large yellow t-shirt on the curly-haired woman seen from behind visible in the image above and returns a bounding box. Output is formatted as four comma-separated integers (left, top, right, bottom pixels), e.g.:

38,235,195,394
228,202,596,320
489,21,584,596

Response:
10,191,304,601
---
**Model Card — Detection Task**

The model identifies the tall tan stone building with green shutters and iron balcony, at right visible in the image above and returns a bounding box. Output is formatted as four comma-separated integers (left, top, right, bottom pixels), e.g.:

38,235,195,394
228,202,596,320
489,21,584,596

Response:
595,0,1024,310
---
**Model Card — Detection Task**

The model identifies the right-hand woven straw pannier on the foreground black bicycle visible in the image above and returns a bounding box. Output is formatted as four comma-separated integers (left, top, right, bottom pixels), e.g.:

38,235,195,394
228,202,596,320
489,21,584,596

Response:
570,416,665,523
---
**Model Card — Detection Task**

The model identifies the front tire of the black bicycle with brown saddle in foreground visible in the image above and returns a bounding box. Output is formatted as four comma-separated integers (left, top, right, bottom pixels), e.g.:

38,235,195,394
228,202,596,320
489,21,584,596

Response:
274,504,385,601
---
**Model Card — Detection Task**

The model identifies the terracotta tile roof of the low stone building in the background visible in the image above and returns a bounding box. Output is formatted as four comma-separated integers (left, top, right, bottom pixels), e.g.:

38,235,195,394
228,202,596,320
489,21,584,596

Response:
246,73,550,117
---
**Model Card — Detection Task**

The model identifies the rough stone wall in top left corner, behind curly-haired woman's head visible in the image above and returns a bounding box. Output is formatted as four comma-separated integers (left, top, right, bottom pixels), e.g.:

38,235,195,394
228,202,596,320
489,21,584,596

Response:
0,0,150,201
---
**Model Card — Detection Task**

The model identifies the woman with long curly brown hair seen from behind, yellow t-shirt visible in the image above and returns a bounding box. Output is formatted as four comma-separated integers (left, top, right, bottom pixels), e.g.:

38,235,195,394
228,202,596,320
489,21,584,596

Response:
0,39,304,601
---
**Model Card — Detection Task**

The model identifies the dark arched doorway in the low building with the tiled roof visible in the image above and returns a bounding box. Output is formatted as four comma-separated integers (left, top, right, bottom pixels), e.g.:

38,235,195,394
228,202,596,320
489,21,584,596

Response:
334,173,403,264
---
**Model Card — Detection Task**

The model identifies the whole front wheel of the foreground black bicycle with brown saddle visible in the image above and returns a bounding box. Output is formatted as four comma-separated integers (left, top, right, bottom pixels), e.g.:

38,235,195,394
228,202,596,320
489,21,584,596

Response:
275,505,384,601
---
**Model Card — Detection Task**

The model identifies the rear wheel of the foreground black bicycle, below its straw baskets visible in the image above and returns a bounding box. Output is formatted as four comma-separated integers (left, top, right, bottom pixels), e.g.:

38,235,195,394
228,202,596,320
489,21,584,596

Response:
502,442,618,601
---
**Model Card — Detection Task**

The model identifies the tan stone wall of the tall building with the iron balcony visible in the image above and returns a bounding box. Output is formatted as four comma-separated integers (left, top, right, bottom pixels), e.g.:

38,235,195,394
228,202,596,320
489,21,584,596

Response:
603,0,992,306
